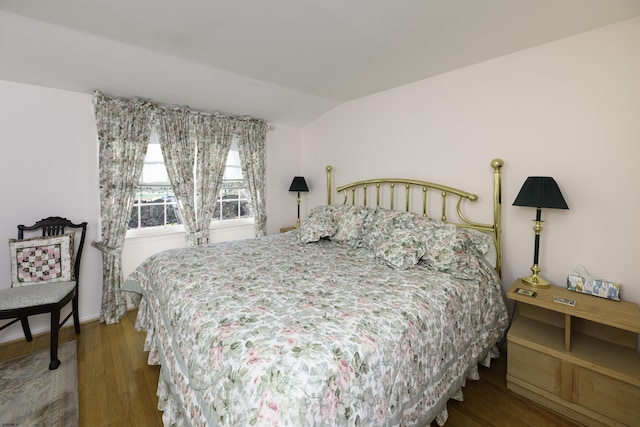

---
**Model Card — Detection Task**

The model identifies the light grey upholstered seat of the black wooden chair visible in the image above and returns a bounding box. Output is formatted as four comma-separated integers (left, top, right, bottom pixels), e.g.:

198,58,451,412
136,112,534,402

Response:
0,281,76,310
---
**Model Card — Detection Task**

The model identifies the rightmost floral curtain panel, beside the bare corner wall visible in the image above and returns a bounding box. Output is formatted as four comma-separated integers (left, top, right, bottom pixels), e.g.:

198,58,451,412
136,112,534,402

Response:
238,120,268,237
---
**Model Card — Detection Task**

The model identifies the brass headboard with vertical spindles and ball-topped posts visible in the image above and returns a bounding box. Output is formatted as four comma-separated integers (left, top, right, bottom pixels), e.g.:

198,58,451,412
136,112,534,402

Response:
327,159,504,274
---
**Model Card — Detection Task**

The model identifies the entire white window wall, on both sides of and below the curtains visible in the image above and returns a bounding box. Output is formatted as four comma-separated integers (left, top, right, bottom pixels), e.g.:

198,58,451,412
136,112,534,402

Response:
0,80,300,342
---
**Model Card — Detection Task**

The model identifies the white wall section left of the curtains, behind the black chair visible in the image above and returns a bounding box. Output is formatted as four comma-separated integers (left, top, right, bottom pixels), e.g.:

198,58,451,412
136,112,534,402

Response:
0,81,102,341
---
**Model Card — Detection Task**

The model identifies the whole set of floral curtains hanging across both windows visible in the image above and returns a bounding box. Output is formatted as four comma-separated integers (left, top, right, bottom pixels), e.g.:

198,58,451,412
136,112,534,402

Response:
93,92,267,324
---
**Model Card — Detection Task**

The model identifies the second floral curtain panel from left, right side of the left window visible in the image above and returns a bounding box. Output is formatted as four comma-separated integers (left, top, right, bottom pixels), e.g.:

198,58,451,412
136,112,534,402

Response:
158,109,198,242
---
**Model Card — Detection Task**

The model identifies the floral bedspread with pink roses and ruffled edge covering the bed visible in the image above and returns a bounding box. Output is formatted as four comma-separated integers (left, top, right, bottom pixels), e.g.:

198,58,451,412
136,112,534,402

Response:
125,231,508,426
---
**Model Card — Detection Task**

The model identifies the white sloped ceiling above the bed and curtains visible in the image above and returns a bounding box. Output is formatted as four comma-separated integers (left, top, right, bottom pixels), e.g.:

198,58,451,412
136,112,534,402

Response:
0,0,640,126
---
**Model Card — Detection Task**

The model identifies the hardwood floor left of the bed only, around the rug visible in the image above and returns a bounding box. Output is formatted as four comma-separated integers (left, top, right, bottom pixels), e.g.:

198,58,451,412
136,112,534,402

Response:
0,311,162,427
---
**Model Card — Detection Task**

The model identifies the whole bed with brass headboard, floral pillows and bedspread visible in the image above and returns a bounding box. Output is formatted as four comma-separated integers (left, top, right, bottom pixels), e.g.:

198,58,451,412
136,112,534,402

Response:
124,160,508,426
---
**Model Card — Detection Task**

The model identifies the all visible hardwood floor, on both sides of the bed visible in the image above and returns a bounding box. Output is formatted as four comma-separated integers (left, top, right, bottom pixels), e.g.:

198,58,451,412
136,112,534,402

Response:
0,311,578,427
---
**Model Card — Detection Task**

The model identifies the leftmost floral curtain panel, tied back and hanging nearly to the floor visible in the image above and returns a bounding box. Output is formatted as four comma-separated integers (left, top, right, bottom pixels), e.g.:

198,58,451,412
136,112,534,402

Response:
94,92,155,324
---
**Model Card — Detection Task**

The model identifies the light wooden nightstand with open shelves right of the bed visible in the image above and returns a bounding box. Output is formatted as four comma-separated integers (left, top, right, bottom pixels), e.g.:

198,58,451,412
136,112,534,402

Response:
507,279,640,425
